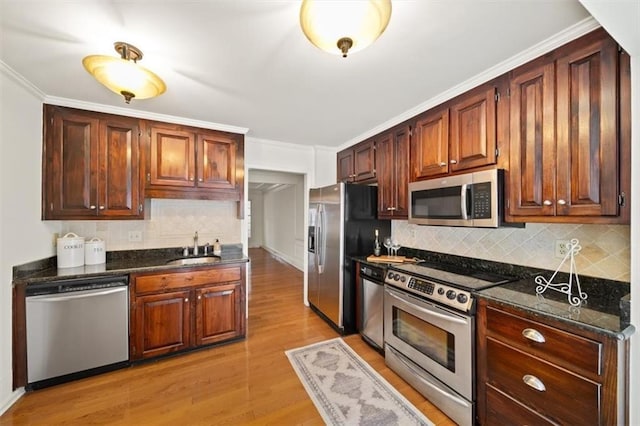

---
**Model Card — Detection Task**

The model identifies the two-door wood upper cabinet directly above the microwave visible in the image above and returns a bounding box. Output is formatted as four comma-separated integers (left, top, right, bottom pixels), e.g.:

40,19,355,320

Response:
411,81,498,181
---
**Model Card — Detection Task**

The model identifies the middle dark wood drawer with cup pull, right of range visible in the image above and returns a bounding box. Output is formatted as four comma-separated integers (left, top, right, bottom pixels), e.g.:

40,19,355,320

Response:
486,338,602,424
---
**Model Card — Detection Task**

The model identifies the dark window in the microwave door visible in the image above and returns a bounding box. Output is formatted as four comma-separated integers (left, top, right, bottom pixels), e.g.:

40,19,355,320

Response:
411,186,462,219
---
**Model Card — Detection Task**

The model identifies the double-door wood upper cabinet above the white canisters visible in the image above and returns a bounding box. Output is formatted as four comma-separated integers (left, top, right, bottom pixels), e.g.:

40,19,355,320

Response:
42,105,143,219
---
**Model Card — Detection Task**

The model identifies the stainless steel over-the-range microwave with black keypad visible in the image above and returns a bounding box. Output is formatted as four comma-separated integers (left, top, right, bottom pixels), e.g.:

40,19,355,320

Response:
409,169,504,228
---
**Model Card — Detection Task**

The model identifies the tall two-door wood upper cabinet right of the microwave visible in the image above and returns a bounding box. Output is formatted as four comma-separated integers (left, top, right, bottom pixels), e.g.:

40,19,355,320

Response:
507,30,629,222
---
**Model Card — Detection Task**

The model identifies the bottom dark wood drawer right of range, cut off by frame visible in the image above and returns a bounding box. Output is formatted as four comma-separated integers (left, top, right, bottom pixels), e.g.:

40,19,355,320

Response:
485,385,553,425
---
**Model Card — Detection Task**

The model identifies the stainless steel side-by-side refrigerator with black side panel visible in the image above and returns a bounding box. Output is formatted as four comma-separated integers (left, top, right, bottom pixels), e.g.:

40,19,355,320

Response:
307,183,391,334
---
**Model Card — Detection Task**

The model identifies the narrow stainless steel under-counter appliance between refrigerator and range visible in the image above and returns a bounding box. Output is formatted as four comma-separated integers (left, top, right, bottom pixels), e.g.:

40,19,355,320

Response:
360,265,385,351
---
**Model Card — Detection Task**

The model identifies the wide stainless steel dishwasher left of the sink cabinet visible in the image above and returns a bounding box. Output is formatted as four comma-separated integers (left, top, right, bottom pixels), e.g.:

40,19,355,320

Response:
26,276,129,389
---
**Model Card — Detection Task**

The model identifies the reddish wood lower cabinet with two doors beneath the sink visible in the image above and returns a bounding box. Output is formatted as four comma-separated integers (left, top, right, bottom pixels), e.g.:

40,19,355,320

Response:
130,264,246,361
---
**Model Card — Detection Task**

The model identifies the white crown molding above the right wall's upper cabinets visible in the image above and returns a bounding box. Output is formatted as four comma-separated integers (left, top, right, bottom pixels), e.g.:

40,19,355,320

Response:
338,17,600,151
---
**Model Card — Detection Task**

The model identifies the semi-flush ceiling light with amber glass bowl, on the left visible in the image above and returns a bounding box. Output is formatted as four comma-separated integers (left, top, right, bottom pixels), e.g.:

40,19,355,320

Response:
82,41,167,103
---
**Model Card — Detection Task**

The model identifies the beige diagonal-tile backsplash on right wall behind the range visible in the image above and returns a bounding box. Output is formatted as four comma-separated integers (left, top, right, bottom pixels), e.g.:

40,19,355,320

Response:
392,220,631,281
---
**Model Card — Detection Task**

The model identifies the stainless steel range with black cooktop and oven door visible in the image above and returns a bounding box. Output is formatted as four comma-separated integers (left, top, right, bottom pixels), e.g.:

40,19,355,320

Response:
384,263,509,425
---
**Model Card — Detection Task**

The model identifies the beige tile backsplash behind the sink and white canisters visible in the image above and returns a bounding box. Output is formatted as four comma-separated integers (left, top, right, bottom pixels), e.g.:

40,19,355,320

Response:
61,199,241,251
